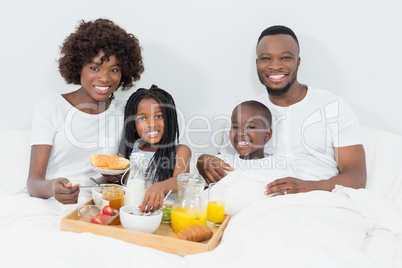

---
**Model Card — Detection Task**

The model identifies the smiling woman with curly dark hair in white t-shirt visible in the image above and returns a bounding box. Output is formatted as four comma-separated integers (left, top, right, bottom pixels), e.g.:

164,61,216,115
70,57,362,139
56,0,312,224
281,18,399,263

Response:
27,19,144,204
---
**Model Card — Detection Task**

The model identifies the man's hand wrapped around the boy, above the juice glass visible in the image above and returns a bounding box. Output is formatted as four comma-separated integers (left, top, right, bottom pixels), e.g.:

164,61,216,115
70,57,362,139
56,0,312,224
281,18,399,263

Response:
197,154,233,183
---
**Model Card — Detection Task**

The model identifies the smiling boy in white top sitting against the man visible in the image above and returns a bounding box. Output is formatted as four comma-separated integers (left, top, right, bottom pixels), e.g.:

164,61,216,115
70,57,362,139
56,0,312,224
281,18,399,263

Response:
210,101,290,215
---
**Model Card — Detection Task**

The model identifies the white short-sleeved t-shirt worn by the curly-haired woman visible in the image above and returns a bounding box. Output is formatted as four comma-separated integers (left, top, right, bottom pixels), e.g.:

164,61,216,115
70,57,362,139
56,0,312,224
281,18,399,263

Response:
31,94,126,185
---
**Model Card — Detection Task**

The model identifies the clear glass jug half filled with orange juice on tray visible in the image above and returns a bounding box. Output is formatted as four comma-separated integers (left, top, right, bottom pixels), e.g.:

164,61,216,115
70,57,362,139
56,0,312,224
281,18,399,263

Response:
171,173,207,232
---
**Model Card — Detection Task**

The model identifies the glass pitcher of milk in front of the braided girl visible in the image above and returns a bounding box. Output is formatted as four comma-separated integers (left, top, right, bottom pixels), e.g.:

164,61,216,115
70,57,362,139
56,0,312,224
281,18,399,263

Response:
124,153,150,206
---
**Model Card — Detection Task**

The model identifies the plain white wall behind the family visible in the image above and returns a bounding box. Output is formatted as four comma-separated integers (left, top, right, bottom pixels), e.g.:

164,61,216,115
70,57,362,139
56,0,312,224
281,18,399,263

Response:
0,0,402,161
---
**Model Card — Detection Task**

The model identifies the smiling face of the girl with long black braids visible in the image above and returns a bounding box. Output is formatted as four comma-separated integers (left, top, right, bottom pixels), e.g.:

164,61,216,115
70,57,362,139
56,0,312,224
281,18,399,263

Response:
135,98,165,151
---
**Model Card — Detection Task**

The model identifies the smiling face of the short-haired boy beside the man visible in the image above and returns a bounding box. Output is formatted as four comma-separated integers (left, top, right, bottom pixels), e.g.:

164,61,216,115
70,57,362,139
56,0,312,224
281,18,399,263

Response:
230,106,271,159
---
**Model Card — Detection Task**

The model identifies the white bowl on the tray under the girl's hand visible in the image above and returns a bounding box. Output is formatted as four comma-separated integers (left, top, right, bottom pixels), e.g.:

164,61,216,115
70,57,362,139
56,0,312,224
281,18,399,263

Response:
120,205,162,234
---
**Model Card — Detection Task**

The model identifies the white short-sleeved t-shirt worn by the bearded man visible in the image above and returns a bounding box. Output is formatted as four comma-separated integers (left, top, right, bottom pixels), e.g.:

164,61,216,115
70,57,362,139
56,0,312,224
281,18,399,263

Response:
220,87,362,180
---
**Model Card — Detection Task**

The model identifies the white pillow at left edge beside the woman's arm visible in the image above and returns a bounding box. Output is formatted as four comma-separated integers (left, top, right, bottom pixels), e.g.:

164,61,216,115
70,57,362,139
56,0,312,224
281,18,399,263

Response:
0,130,31,194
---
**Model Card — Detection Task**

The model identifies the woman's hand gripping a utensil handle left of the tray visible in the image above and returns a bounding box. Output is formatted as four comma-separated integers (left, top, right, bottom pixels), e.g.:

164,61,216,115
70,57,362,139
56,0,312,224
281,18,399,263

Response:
52,178,80,204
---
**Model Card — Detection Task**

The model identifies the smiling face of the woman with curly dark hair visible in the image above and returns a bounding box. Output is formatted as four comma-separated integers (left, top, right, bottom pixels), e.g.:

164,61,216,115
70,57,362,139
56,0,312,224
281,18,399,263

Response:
81,50,122,101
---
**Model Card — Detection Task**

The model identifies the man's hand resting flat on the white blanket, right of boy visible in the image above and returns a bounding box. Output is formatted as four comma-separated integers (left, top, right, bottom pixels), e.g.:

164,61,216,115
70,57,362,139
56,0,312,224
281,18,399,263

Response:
265,177,317,196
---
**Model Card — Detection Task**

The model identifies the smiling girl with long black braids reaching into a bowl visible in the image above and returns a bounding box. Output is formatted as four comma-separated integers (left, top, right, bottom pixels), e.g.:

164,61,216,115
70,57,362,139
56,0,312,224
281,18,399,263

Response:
120,85,191,212
